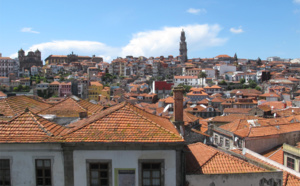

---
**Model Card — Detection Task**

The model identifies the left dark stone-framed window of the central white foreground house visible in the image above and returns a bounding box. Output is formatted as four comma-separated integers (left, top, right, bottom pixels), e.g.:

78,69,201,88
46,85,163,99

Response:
88,161,111,186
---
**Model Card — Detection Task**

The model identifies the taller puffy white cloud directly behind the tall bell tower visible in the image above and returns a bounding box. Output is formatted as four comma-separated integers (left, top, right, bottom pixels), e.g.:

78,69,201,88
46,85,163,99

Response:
122,24,227,57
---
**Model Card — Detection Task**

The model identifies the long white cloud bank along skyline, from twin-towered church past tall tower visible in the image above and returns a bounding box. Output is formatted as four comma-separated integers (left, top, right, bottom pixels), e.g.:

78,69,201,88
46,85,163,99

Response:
10,24,227,62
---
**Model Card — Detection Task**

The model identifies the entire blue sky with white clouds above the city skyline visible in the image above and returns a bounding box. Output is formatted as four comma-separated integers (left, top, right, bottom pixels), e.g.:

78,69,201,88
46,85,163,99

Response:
0,0,300,61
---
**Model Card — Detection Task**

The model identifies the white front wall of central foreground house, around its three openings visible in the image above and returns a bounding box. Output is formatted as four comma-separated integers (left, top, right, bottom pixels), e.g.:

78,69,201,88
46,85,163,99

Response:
73,150,176,186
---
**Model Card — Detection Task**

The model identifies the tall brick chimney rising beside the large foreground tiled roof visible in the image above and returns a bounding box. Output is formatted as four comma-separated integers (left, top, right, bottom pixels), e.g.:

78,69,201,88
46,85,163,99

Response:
173,87,184,137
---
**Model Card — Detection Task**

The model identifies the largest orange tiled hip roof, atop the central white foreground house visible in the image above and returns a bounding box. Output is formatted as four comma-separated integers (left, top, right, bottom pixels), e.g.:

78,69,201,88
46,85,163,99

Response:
64,102,184,143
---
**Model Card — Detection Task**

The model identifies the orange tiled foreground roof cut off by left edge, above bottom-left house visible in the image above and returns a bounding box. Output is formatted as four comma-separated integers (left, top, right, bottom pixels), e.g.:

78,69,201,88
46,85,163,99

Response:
0,111,65,143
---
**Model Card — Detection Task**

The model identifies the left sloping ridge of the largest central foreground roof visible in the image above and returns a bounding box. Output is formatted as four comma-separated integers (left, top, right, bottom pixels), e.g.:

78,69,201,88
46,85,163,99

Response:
62,102,126,136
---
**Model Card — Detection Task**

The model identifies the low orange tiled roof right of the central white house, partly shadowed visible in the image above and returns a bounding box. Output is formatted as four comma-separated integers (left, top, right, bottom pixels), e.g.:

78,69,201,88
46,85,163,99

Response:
186,142,267,174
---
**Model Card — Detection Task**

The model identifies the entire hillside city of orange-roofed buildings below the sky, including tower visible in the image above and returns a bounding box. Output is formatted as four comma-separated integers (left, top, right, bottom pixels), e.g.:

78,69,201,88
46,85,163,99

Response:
0,31,300,186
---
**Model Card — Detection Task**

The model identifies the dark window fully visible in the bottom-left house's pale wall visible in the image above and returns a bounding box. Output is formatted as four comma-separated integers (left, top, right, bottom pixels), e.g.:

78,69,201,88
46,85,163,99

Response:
35,159,52,186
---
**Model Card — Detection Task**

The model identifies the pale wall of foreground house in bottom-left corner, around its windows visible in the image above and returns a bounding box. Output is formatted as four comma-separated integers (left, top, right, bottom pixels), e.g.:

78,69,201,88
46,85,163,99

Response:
0,144,64,186
